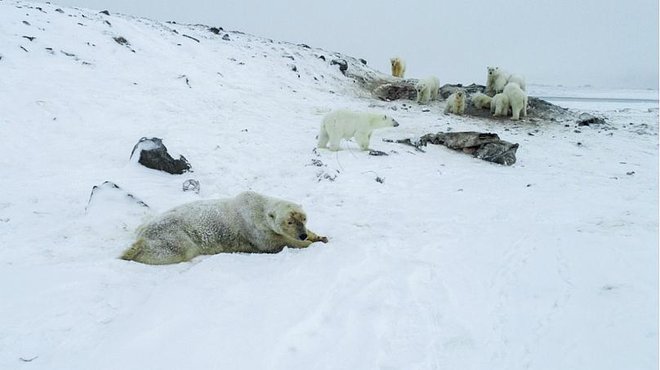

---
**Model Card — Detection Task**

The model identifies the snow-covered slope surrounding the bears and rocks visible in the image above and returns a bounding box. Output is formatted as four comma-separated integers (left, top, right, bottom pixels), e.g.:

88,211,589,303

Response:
0,0,658,370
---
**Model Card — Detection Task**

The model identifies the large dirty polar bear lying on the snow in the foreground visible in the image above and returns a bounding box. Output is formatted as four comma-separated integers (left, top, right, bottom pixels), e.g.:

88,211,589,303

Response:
121,191,328,265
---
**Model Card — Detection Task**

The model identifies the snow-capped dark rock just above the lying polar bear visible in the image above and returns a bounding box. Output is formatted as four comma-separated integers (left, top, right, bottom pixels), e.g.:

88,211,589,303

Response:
131,137,190,175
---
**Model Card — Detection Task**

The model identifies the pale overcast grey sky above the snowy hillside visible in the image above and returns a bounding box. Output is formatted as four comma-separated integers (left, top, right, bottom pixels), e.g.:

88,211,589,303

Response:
42,0,658,89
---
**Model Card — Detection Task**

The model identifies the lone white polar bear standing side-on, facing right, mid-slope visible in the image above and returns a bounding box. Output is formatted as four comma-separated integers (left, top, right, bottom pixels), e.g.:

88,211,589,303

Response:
317,109,399,151
